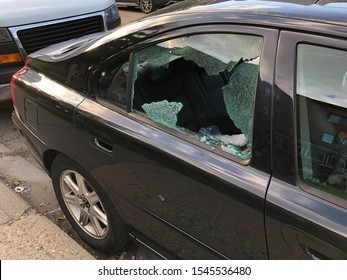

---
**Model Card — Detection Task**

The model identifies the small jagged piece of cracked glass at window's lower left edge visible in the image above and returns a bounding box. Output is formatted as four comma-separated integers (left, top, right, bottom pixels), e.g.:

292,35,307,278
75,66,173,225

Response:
142,100,183,129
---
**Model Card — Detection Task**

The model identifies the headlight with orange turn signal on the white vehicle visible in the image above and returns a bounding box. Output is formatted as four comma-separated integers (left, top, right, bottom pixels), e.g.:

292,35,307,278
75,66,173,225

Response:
0,28,23,66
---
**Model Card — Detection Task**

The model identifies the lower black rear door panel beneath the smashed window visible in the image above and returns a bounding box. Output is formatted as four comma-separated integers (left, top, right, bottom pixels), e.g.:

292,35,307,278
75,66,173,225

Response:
76,99,269,259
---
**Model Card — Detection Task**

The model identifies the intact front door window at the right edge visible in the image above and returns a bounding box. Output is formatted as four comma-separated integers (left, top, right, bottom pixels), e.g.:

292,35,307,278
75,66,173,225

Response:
296,44,347,203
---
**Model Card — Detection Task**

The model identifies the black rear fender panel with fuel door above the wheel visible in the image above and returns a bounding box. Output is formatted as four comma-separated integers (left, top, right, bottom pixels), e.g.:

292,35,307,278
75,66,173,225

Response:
14,65,89,170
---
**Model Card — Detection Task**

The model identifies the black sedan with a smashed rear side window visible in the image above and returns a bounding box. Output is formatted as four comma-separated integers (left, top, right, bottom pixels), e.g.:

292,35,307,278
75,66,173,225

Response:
12,0,347,259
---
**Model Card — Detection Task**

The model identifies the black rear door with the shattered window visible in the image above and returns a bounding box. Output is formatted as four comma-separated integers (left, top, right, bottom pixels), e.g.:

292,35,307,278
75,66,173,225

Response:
76,25,278,259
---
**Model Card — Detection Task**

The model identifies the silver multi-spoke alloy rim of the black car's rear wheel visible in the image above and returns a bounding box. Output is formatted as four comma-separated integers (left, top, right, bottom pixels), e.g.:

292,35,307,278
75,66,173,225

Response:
60,170,108,239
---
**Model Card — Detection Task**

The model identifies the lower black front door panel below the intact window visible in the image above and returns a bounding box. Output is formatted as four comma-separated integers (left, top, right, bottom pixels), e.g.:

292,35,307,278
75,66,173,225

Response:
266,179,347,260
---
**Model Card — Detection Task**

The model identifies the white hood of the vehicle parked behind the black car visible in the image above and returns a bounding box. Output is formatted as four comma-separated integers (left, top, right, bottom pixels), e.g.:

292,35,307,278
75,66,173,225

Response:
0,0,115,27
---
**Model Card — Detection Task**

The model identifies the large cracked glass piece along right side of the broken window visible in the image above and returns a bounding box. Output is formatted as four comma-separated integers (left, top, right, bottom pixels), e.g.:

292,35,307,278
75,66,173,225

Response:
223,63,258,143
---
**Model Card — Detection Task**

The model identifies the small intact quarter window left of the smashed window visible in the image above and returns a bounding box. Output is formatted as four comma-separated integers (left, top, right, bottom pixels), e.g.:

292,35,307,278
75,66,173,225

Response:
96,61,129,108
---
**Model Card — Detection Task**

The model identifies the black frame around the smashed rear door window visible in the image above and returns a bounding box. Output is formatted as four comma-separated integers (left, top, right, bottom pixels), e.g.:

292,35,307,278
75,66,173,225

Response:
92,22,278,173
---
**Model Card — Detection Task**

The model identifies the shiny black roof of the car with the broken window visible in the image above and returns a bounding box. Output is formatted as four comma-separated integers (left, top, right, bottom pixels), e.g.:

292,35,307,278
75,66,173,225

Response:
155,0,347,26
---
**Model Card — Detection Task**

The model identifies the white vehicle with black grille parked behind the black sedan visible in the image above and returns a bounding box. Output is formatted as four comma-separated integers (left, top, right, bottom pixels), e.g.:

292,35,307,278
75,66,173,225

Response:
0,0,120,106
